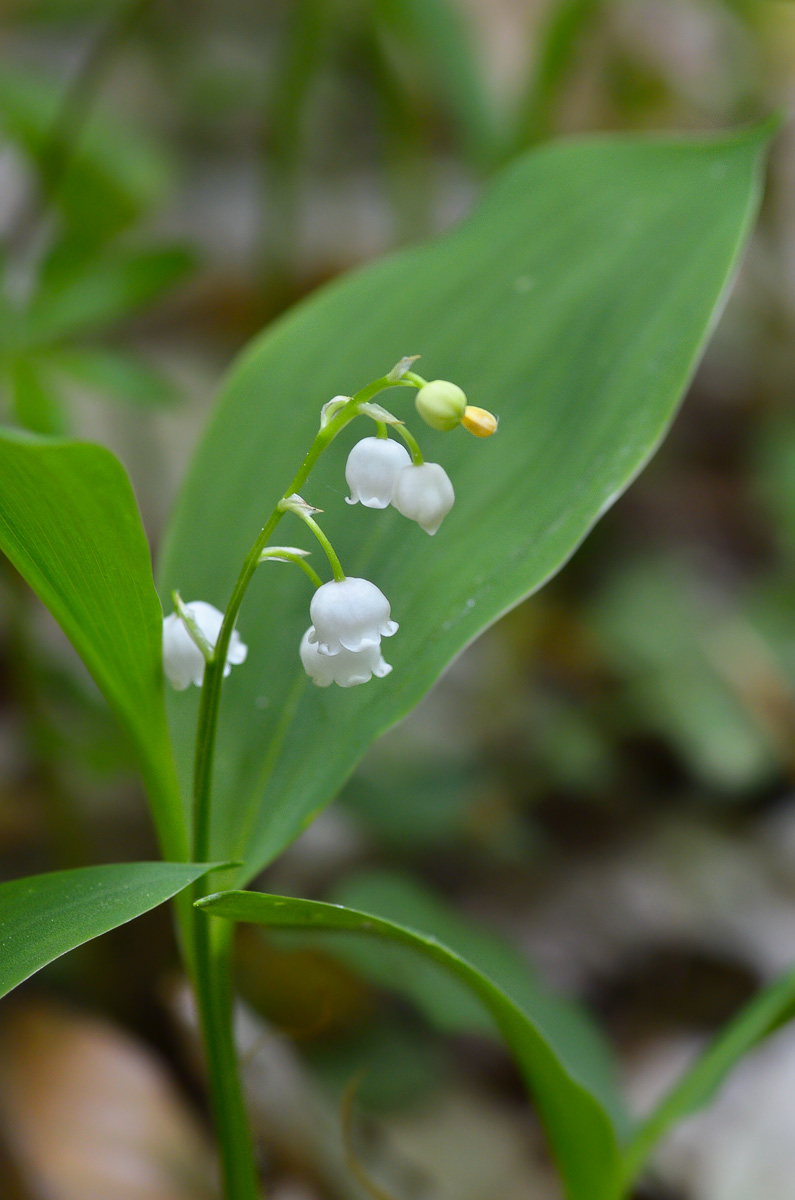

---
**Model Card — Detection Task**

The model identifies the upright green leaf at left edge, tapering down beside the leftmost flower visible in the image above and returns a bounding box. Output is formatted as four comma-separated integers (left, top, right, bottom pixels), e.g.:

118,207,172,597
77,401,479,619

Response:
0,431,187,858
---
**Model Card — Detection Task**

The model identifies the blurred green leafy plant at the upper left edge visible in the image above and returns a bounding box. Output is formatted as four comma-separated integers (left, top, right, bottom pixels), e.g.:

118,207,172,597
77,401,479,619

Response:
0,66,196,434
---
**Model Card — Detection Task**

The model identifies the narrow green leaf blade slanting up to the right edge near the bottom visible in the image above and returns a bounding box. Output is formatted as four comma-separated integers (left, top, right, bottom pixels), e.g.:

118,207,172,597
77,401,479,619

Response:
624,971,795,1183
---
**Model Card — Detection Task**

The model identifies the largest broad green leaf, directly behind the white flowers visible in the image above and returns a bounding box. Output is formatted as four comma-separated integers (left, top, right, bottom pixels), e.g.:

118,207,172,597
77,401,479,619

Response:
160,130,764,877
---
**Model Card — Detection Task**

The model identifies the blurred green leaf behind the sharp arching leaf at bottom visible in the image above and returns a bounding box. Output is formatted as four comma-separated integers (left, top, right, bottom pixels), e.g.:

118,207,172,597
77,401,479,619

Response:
331,871,629,1132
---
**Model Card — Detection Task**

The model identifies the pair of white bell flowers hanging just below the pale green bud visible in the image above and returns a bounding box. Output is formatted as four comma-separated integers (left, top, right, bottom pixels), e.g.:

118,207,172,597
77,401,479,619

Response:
345,438,455,534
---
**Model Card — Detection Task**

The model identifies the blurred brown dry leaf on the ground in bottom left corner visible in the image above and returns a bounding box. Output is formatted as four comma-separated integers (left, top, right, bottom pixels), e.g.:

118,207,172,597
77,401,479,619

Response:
0,1002,217,1200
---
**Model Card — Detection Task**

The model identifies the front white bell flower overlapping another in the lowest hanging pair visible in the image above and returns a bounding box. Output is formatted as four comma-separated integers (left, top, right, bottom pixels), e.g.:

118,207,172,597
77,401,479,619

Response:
309,578,398,654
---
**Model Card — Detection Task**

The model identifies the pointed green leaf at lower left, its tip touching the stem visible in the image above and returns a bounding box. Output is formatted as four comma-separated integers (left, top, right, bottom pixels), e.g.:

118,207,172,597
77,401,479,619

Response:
0,863,213,996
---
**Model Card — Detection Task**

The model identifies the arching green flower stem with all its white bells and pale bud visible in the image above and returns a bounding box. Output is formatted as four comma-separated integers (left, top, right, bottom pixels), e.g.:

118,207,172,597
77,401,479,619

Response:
158,358,497,1200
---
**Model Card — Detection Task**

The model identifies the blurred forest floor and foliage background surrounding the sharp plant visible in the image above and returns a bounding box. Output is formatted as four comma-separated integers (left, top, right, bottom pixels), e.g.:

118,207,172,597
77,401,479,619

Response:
0,0,795,1200
